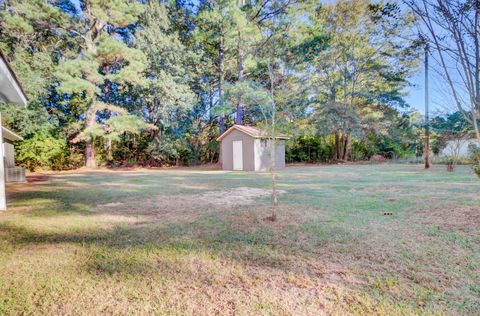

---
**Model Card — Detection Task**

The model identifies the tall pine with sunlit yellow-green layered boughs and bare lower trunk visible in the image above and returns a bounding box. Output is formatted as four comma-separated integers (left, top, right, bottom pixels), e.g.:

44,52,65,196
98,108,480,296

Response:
56,0,147,167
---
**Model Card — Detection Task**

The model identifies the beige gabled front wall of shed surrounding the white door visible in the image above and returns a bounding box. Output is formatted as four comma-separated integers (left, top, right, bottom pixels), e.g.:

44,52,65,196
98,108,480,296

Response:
221,130,255,171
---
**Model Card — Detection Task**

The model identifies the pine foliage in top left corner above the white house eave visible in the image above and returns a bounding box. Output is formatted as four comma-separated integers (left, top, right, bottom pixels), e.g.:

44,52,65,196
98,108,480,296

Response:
0,0,74,101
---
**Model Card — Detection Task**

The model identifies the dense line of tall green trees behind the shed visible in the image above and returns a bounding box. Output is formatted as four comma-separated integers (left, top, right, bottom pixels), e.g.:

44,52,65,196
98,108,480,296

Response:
0,0,476,170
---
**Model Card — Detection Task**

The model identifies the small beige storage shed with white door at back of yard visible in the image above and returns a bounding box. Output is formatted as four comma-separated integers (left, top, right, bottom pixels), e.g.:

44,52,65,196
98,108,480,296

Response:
217,125,288,171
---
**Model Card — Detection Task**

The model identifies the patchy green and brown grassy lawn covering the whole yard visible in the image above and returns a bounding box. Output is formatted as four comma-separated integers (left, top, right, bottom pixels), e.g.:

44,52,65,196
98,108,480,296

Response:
0,165,480,315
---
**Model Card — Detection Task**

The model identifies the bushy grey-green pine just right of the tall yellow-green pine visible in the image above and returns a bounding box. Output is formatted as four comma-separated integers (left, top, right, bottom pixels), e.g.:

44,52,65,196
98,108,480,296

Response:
135,1,195,136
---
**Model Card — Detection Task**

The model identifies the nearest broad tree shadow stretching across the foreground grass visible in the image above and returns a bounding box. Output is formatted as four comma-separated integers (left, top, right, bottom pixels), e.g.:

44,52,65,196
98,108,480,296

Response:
0,212,326,275
